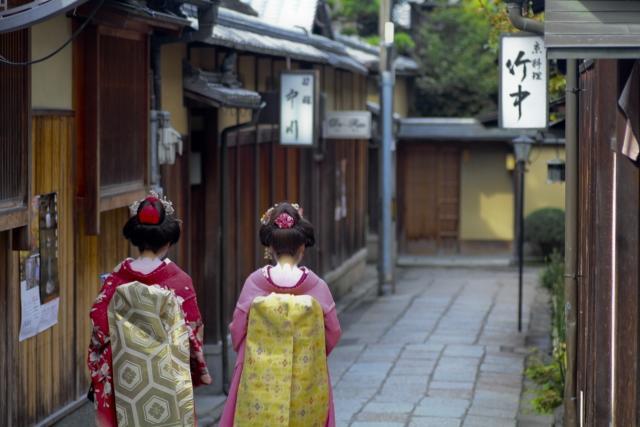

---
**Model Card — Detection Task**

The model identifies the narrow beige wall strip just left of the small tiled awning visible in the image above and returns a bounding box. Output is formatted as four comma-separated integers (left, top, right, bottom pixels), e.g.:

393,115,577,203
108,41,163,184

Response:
160,43,189,135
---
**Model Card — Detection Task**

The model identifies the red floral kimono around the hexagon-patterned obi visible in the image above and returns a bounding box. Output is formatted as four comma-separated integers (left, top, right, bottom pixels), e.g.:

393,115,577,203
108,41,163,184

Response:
87,259,208,427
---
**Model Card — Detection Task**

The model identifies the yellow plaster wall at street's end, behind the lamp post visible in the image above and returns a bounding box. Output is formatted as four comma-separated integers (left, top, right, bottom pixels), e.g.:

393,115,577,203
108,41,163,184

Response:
460,143,564,241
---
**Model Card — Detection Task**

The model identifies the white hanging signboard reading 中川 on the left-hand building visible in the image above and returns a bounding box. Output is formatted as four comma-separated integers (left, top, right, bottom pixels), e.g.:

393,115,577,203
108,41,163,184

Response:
280,70,318,146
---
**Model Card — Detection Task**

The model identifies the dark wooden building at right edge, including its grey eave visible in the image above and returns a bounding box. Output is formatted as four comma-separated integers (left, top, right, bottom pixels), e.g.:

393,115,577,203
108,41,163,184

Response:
545,0,640,427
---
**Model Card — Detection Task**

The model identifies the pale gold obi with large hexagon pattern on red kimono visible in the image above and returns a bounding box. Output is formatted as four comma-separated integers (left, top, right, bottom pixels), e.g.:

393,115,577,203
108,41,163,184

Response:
109,282,195,427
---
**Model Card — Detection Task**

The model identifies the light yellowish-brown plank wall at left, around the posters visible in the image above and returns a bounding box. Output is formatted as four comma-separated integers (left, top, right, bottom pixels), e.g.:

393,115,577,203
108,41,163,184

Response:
0,115,76,425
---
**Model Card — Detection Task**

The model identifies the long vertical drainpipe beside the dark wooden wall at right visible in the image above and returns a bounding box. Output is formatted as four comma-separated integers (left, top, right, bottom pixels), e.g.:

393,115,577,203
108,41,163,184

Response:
564,59,579,427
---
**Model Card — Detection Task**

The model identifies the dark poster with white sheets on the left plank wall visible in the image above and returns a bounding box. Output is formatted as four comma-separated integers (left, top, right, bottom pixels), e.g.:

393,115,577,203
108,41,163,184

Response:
19,193,60,341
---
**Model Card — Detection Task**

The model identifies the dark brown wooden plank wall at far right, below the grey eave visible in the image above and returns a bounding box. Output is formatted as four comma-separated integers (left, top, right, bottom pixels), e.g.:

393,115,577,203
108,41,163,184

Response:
577,60,640,426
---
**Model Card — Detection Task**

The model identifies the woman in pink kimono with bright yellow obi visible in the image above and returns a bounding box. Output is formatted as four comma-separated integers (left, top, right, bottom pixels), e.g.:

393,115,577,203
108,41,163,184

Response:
220,203,341,427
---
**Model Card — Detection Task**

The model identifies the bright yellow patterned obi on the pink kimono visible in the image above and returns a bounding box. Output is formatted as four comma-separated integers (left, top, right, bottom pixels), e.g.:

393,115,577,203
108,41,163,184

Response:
235,293,329,427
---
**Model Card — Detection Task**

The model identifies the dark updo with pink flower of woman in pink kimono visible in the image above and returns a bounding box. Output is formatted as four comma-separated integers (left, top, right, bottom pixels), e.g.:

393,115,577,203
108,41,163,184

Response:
260,202,316,257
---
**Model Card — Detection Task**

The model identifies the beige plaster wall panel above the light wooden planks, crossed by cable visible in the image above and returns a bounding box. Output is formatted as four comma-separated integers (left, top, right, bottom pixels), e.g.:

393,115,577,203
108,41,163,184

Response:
31,15,73,110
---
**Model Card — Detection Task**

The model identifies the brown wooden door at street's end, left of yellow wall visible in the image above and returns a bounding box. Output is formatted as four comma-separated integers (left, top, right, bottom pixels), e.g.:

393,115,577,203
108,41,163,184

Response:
398,143,460,254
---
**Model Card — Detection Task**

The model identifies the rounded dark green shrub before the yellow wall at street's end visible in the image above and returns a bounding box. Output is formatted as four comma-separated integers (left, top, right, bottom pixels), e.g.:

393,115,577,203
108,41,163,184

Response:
524,208,564,257
